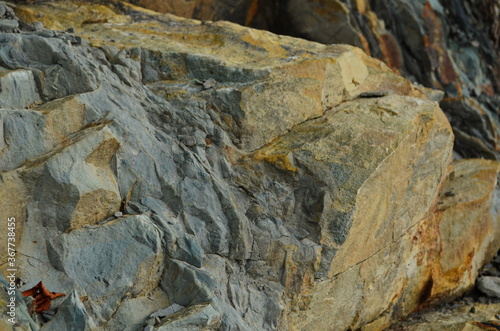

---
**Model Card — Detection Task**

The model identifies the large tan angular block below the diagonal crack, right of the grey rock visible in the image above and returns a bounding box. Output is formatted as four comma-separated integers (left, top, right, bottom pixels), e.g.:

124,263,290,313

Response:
239,96,452,330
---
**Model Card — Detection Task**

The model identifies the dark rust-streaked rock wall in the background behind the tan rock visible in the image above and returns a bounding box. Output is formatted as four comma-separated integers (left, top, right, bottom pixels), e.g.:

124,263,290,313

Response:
124,0,500,159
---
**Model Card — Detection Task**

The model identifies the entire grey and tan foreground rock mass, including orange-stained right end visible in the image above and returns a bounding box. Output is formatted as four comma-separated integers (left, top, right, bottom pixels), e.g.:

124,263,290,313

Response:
0,3,500,330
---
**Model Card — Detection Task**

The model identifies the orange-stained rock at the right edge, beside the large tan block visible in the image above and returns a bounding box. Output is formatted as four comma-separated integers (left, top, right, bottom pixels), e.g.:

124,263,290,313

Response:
429,159,500,300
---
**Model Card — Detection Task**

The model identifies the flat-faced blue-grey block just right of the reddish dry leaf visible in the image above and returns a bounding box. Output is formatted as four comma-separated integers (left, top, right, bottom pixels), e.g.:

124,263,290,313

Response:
48,216,162,319
